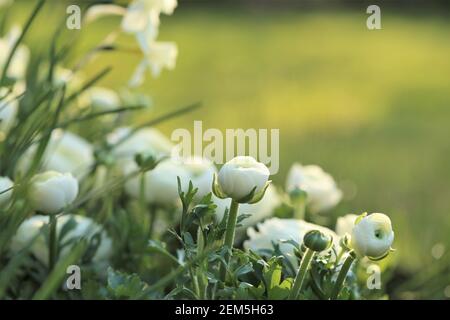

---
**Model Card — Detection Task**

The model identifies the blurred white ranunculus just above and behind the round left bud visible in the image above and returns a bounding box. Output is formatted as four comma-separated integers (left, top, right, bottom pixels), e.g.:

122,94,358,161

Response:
43,129,95,177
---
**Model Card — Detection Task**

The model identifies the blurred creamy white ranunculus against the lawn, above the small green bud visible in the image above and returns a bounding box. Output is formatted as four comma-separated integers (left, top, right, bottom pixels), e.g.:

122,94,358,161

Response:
286,163,342,213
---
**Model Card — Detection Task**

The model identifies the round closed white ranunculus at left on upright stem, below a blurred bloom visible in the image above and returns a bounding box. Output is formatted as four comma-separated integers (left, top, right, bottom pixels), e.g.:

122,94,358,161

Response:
29,171,78,214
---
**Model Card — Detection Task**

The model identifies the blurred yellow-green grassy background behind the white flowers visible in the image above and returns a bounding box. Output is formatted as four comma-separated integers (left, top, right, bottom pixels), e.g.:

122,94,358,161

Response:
8,1,450,298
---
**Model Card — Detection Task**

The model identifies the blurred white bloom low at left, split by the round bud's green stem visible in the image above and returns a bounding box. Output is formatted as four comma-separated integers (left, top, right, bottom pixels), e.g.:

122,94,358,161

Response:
11,214,112,265
